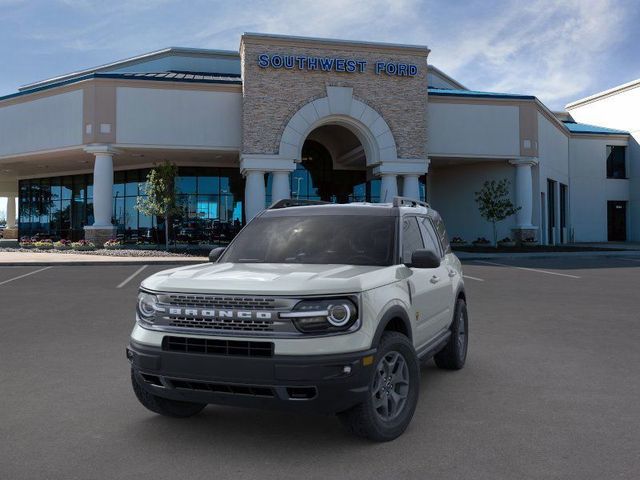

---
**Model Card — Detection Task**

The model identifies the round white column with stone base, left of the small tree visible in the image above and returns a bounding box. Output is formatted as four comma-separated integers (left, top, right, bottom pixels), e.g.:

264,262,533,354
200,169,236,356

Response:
84,145,118,247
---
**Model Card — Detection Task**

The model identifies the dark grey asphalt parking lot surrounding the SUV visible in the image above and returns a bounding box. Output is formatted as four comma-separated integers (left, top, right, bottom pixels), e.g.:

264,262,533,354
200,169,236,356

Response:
0,258,640,480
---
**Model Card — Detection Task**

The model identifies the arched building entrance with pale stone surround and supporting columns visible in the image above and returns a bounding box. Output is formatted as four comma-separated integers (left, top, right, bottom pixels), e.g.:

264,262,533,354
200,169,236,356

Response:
245,86,427,220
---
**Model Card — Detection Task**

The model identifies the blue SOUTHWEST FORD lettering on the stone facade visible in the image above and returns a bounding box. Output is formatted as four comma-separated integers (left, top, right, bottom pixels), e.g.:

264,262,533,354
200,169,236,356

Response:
258,53,418,77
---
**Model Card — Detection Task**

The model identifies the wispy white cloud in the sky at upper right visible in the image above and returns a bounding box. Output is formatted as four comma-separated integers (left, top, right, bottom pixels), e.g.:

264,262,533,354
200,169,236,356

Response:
433,0,629,108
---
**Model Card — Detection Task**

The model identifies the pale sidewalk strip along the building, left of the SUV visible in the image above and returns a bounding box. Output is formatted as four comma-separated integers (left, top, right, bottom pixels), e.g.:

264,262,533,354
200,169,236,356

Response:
0,252,208,268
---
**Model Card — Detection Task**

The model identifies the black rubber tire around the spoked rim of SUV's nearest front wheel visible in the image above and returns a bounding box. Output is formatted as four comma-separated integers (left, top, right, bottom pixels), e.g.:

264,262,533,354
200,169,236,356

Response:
338,332,420,442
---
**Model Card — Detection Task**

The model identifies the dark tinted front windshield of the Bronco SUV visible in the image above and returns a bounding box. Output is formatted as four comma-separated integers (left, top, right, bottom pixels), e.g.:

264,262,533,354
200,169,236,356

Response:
220,215,397,266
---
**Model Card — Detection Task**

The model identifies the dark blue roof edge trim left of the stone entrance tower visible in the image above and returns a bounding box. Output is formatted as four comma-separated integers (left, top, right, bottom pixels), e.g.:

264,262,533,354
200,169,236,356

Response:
0,72,242,101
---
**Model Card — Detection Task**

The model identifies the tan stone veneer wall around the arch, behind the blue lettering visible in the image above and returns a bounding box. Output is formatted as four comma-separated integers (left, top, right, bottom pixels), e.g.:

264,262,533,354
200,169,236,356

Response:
240,37,428,159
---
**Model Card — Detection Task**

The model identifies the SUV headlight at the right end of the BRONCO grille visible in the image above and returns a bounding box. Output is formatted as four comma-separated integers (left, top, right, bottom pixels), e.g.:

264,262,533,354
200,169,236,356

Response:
280,298,358,333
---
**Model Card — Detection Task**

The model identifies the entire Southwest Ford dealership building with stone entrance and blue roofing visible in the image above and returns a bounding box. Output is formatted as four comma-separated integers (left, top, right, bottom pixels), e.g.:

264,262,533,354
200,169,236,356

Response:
0,34,640,244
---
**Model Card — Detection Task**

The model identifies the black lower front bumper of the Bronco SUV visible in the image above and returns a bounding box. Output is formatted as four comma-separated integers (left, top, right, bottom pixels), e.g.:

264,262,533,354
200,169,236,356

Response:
127,340,376,413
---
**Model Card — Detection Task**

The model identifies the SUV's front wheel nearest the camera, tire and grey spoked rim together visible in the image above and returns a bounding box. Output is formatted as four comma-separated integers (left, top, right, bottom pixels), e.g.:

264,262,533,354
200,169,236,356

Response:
338,332,420,442
